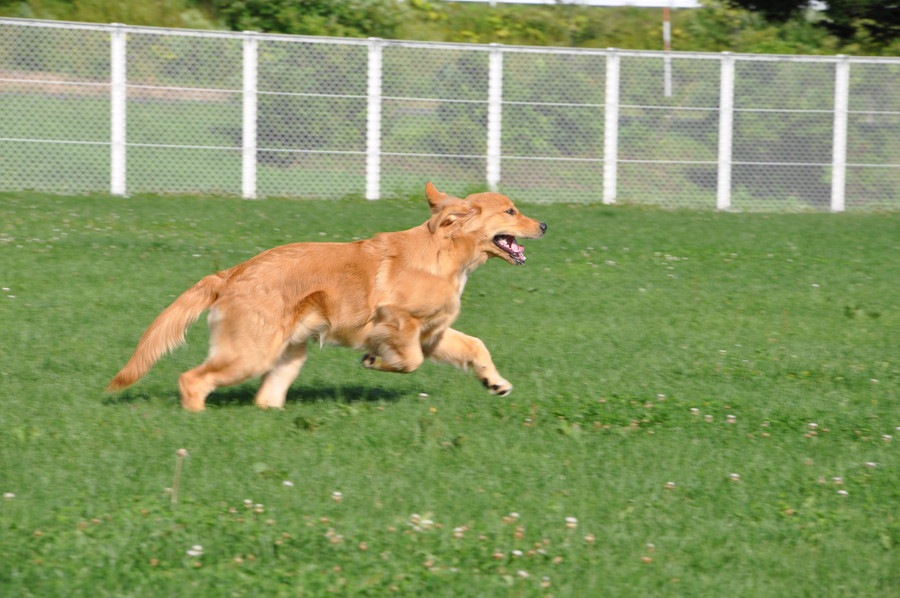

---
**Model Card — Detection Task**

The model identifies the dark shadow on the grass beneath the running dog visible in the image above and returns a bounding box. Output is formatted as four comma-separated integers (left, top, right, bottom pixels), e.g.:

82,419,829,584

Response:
103,384,411,407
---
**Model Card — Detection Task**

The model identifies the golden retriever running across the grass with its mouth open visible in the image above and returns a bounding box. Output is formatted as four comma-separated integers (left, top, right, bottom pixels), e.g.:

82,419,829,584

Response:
107,183,547,411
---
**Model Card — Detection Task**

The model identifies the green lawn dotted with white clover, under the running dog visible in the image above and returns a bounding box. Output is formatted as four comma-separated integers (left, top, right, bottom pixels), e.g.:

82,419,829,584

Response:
0,190,900,597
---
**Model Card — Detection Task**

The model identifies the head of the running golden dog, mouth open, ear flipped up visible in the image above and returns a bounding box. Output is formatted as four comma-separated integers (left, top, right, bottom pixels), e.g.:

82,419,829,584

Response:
425,183,547,266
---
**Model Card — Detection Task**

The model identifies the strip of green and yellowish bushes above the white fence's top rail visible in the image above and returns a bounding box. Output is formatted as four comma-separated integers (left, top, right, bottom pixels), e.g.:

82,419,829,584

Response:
0,0,900,55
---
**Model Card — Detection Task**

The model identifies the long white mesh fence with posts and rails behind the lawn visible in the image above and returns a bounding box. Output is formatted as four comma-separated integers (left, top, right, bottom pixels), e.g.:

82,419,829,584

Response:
0,19,900,211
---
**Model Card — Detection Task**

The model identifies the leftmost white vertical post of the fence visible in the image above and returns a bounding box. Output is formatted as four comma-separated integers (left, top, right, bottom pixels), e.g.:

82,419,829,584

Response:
109,23,127,195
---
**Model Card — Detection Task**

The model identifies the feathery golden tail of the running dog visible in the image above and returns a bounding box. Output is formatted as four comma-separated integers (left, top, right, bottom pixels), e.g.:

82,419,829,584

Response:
106,274,225,391
